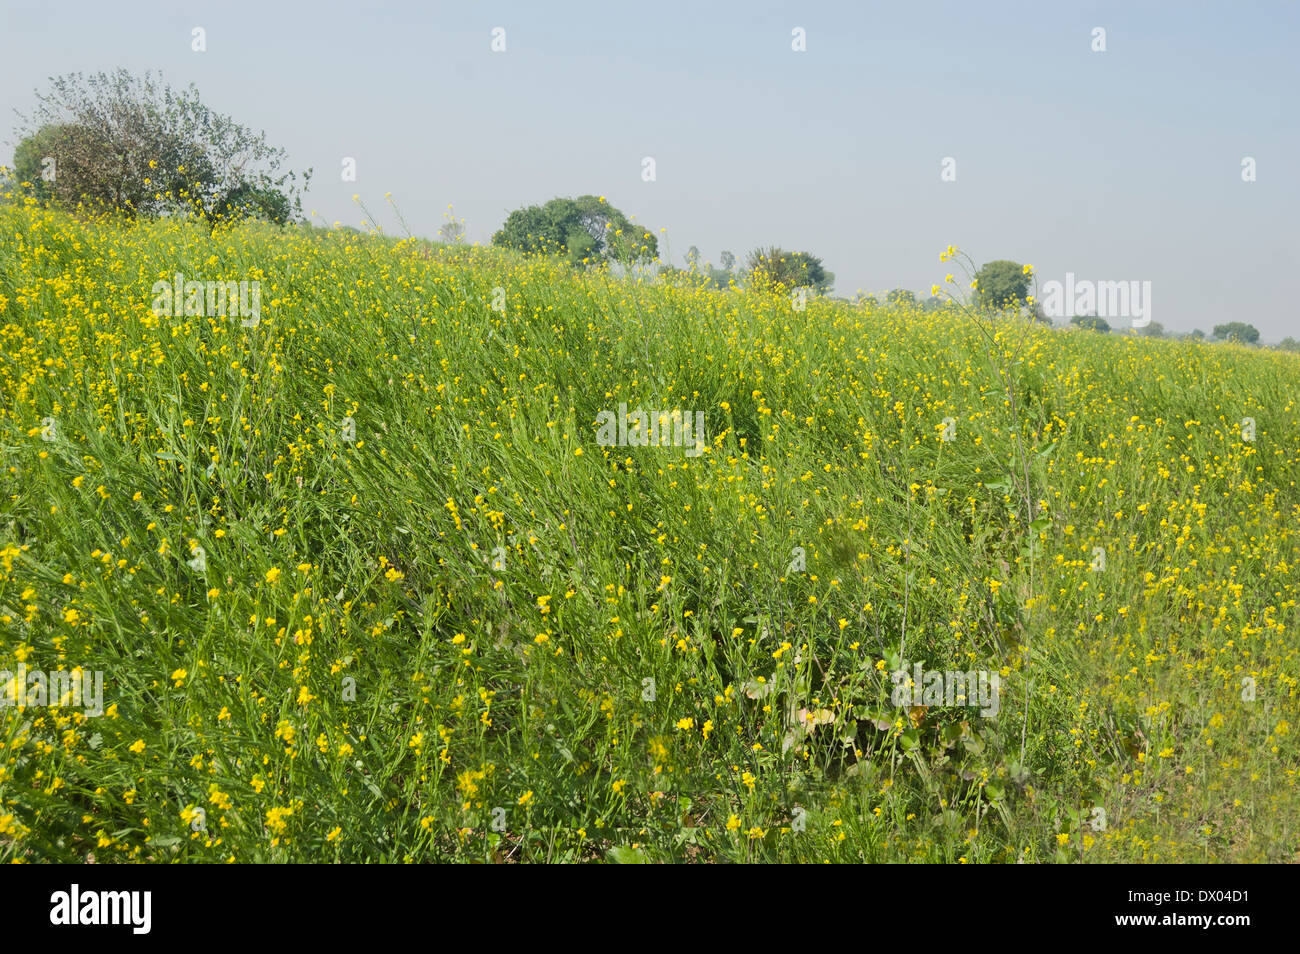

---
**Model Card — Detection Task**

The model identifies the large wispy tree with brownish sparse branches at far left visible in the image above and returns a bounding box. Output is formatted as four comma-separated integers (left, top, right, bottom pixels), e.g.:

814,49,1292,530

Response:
14,69,311,222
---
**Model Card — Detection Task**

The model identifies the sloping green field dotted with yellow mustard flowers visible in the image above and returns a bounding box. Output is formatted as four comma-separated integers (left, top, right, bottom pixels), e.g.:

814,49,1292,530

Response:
0,203,1300,863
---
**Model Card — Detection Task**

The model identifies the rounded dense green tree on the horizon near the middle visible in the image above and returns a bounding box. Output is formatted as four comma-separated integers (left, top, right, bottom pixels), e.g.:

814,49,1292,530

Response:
491,195,659,265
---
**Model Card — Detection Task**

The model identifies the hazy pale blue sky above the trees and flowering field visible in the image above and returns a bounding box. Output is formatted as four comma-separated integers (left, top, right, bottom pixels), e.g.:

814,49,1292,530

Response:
0,0,1300,341
